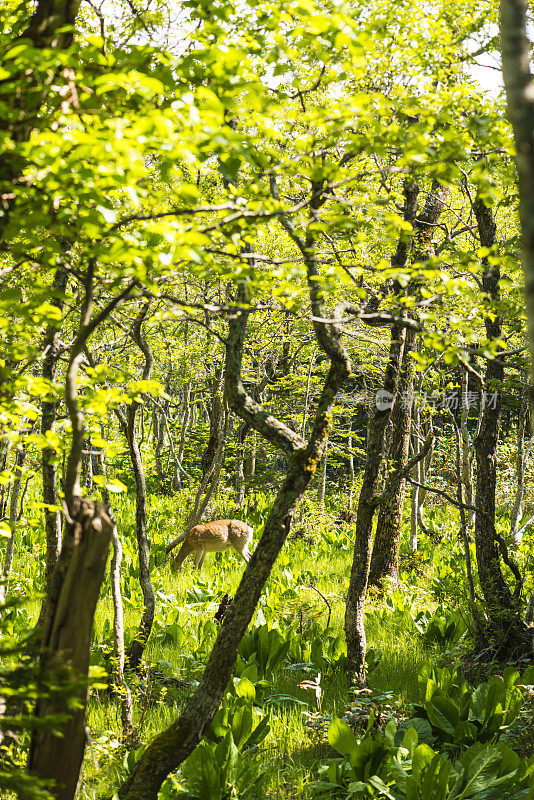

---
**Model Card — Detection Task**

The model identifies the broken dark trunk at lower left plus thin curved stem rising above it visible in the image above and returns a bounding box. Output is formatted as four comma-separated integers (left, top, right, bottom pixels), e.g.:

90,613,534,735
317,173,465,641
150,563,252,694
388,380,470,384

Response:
28,252,134,800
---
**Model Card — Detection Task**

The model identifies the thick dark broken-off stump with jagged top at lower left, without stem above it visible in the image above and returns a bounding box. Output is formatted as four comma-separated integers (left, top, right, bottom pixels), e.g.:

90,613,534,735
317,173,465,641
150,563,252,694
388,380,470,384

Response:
28,498,113,800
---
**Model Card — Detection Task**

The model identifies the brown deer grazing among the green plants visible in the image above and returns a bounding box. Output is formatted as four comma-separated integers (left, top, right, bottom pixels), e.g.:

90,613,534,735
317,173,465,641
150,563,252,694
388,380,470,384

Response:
171,519,254,570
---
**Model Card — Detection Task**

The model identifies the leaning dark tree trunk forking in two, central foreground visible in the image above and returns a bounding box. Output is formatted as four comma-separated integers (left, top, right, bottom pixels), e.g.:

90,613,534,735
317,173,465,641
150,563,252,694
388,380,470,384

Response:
119,198,349,800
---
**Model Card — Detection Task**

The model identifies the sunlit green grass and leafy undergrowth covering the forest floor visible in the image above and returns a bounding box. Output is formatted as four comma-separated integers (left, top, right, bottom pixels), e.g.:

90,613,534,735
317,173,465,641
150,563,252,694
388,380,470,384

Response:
4,495,532,800
